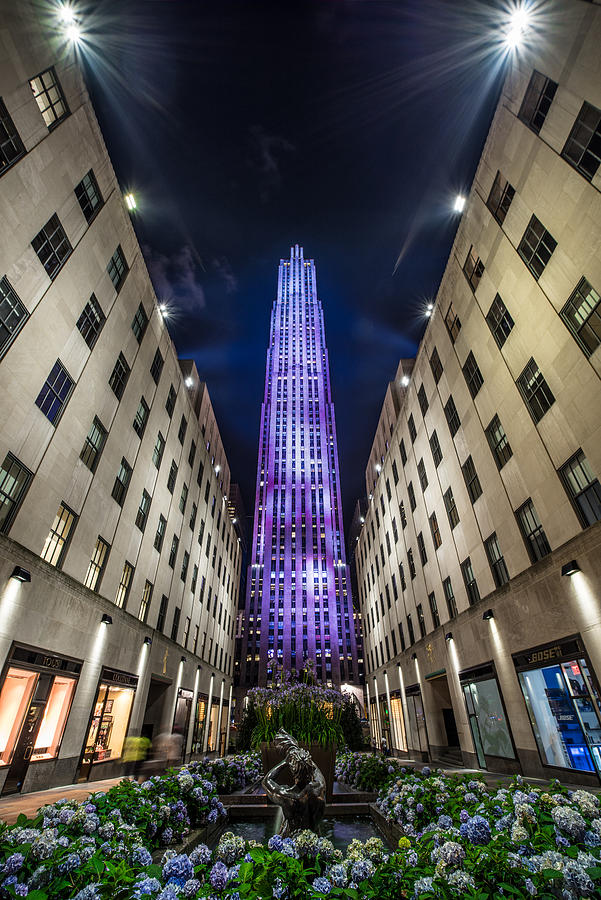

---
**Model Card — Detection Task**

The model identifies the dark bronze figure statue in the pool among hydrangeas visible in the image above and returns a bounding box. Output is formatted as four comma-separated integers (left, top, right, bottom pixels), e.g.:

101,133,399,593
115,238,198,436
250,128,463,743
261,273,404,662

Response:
263,728,326,837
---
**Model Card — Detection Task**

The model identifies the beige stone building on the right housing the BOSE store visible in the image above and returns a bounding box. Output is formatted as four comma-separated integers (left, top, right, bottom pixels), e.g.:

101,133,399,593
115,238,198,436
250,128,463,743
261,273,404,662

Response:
355,3,601,784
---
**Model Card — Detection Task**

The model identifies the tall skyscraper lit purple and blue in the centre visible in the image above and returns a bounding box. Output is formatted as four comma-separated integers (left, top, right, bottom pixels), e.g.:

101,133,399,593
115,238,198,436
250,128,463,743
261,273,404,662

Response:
240,245,362,687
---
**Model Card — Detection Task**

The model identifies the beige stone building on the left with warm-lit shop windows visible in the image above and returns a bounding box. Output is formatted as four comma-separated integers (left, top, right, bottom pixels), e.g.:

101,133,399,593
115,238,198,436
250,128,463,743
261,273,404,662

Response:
0,2,241,793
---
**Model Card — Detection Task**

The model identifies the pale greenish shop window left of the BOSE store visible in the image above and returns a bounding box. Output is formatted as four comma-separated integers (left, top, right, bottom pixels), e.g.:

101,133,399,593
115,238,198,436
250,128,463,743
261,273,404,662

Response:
459,663,516,771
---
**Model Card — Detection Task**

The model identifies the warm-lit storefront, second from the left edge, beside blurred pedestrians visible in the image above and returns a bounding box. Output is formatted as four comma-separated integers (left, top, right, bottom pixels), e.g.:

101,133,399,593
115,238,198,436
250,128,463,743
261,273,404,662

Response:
79,668,138,781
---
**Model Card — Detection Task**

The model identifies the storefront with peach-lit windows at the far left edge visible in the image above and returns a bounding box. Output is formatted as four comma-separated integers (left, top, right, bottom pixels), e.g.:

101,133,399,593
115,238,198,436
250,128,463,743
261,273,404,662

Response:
0,646,82,794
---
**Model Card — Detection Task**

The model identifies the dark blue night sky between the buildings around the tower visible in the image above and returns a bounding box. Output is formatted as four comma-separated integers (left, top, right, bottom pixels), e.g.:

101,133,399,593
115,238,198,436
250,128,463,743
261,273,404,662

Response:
83,0,502,540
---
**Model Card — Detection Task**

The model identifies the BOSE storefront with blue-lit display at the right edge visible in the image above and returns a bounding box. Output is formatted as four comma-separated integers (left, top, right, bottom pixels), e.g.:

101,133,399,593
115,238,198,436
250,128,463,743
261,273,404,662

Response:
513,635,601,775
